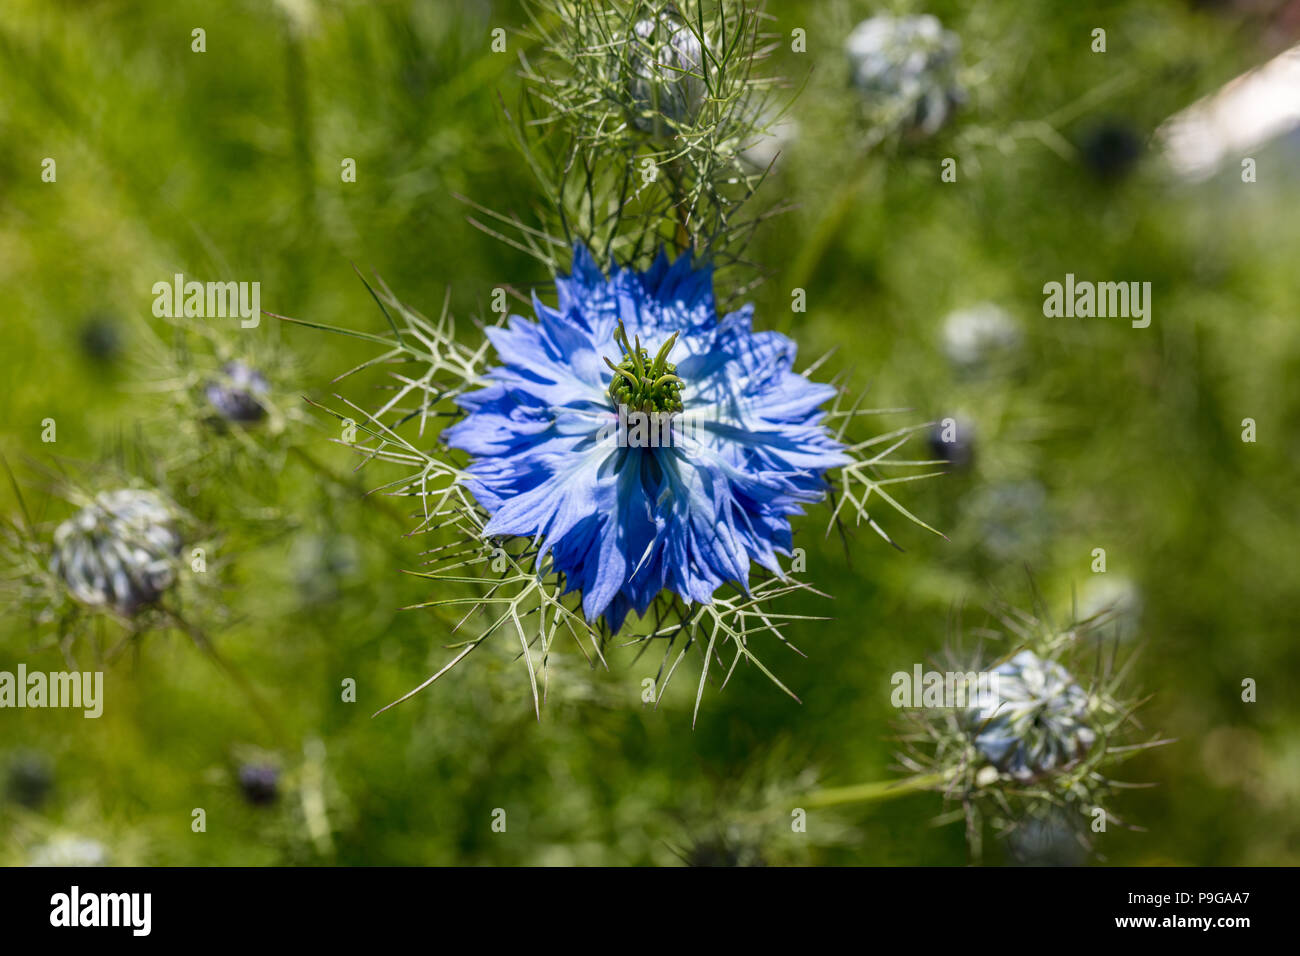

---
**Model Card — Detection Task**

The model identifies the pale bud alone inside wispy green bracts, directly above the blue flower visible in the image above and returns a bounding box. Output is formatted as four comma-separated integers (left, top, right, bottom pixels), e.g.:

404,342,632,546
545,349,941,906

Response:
629,13,707,133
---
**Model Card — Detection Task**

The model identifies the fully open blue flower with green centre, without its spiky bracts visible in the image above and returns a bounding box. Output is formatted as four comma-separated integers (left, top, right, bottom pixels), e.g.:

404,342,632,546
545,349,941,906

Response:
443,246,849,632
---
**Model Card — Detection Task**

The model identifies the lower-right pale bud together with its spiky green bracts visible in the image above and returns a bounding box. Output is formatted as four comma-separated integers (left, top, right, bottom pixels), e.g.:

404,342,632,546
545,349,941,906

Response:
898,606,1170,865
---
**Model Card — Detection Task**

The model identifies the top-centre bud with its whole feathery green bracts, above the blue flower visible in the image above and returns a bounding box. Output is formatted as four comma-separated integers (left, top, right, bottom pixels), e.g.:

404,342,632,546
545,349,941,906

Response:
517,0,783,261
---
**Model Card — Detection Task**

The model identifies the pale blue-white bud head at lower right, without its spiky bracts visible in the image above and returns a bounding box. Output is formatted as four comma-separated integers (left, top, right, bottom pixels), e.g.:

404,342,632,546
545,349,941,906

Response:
967,650,1097,782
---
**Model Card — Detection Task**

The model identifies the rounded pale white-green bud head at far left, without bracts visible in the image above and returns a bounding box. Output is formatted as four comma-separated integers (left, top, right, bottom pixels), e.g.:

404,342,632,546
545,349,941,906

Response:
51,489,181,617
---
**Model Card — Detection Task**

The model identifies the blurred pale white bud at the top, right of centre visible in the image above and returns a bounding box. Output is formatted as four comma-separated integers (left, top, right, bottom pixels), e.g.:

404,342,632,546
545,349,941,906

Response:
844,14,963,137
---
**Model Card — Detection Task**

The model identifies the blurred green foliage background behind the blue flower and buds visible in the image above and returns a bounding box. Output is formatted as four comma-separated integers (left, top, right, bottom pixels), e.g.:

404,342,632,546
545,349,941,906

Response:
0,0,1300,865
